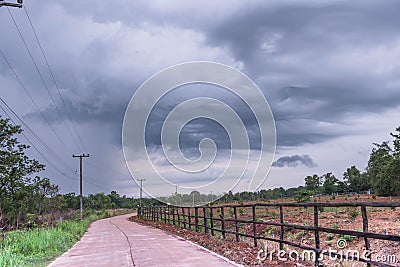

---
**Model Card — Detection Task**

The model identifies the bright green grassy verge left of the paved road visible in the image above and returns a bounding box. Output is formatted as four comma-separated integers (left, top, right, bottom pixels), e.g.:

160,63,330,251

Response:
0,212,133,267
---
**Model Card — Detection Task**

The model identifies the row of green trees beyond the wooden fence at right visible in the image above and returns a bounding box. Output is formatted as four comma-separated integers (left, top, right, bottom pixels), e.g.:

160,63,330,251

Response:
220,127,400,202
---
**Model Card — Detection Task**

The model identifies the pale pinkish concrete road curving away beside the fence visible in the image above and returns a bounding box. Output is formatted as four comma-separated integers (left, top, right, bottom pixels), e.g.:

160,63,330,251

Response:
49,214,237,267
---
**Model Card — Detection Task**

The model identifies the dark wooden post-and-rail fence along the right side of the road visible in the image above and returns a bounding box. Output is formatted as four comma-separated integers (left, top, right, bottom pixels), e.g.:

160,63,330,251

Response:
138,202,400,267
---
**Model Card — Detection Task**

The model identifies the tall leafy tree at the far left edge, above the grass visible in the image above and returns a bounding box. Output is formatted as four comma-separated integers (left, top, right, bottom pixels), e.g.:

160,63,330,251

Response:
0,116,44,228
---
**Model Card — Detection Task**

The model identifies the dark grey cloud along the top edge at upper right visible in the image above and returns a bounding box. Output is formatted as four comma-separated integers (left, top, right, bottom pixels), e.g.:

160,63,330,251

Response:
208,1,400,68
